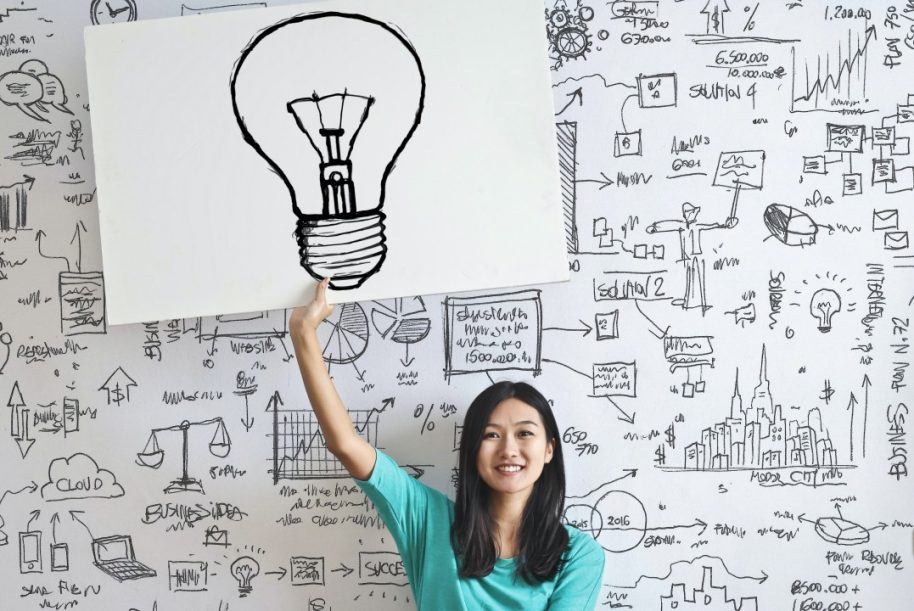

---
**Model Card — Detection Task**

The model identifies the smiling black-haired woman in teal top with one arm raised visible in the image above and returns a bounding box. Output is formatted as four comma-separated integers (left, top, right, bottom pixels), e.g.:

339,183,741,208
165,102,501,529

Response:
289,281,604,611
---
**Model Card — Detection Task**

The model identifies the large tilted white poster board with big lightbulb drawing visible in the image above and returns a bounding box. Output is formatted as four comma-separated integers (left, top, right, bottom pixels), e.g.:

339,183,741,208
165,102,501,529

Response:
86,0,568,323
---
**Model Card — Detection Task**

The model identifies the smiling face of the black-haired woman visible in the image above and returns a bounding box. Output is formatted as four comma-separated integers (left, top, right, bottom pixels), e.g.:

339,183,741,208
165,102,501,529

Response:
476,397,555,497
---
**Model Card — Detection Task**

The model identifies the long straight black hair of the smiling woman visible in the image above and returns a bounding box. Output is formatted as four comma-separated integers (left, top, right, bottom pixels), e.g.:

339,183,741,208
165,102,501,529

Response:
451,382,568,583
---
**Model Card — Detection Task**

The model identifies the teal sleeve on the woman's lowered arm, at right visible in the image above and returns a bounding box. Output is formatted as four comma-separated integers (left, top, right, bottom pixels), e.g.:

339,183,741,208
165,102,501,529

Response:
548,535,606,611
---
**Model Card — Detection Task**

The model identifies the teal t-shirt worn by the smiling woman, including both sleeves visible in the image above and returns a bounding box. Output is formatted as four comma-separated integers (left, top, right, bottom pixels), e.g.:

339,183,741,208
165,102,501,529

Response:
355,450,605,611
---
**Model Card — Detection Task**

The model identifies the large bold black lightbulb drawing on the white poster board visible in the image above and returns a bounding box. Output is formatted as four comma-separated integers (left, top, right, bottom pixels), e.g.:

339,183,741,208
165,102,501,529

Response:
231,12,425,289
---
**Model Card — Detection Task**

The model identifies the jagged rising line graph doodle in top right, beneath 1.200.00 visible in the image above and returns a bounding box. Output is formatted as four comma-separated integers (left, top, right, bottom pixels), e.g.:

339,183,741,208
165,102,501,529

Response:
790,25,876,112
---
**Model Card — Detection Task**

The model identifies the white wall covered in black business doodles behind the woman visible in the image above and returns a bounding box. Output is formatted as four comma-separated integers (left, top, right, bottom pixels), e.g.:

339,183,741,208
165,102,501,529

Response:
0,0,914,611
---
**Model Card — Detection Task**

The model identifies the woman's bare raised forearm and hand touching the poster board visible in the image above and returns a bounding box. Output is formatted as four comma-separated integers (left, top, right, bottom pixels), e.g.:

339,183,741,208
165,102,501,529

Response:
289,278,375,480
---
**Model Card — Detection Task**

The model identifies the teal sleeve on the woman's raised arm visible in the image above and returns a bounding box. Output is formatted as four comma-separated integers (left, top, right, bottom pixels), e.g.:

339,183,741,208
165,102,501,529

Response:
355,449,432,567
